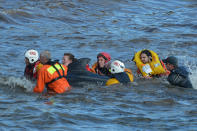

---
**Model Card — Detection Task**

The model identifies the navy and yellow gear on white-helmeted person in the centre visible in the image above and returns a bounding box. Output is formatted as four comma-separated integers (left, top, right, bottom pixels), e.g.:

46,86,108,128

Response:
106,69,133,86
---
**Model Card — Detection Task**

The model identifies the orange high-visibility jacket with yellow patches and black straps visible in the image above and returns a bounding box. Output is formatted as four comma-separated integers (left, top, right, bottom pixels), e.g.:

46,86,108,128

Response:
34,63,70,93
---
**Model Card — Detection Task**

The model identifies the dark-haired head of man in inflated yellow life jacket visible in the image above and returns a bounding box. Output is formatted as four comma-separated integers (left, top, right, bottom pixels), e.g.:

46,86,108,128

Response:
140,50,152,64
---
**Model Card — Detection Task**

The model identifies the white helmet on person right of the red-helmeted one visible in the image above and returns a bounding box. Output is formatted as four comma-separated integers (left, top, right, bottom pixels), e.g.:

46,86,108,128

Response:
111,60,125,74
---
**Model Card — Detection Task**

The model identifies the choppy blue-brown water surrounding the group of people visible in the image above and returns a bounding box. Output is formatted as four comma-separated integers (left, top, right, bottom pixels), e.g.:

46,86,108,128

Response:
0,0,197,130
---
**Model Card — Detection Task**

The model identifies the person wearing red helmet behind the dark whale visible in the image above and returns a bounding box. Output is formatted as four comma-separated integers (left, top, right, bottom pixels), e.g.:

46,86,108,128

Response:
91,52,111,76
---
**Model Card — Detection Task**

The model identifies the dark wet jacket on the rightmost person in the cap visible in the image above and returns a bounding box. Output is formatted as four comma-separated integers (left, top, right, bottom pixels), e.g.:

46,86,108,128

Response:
168,67,192,88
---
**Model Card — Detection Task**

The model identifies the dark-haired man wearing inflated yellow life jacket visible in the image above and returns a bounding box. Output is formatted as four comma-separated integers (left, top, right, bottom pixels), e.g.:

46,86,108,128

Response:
133,50,169,78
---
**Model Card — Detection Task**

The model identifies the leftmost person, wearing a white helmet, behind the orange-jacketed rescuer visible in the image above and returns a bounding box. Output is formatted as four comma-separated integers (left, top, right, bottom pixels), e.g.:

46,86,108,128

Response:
24,49,42,80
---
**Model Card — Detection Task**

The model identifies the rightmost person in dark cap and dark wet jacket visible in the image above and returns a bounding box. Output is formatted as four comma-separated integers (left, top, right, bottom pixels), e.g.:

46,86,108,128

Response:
163,56,193,88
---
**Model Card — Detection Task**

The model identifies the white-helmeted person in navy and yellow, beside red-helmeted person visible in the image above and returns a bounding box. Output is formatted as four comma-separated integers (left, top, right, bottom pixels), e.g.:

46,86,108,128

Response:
106,60,133,86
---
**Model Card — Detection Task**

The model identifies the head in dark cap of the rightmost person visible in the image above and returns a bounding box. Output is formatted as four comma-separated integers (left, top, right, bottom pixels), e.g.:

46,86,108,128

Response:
163,56,178,71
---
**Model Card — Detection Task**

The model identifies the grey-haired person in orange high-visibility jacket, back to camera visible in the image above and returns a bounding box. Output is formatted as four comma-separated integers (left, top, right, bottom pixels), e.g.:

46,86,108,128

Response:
34,51,70,94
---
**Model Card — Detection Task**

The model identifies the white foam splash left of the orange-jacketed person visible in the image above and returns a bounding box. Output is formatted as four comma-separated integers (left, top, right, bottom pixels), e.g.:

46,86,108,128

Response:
2,76,35,92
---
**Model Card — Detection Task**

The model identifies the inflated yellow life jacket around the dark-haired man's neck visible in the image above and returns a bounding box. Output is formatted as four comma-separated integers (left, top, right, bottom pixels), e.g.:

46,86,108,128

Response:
133,50,166,77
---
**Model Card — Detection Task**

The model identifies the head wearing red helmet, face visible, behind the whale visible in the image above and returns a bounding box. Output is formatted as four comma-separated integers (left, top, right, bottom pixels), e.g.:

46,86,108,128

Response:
97,52,111,68
